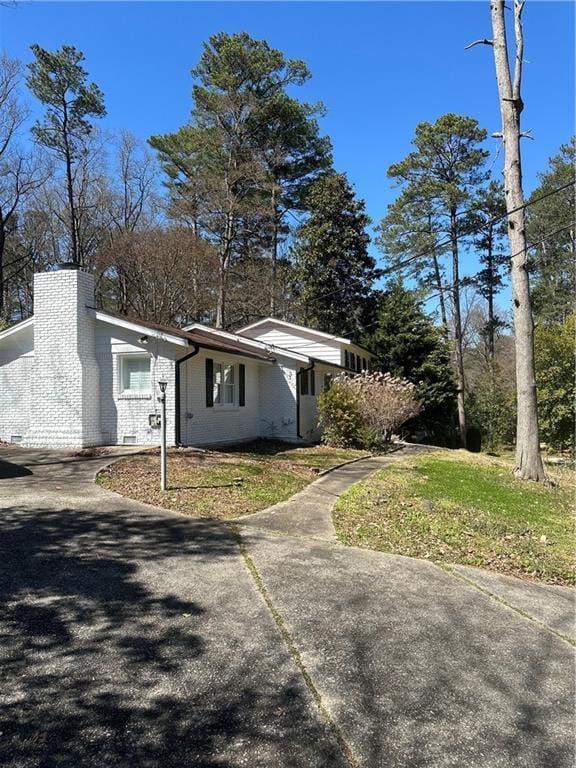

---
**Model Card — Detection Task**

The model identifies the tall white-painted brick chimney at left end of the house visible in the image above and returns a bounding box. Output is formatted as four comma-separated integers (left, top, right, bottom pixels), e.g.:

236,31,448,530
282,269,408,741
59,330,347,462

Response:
26,269,102,448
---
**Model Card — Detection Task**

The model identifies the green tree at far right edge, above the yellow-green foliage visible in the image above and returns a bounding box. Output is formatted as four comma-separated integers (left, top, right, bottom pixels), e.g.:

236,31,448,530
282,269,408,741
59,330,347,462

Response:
526,137,576,325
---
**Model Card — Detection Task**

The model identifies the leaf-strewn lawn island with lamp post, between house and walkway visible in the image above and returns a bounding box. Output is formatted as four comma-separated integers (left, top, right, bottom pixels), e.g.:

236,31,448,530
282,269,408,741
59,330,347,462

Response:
97,441,367,519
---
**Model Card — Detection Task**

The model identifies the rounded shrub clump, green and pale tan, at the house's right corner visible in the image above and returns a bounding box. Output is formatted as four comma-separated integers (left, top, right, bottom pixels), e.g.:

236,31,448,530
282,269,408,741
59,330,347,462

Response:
318,371,420,449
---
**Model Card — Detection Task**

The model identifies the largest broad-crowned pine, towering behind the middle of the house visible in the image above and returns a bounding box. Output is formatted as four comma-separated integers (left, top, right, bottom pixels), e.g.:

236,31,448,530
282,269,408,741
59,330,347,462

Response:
150,32,330,327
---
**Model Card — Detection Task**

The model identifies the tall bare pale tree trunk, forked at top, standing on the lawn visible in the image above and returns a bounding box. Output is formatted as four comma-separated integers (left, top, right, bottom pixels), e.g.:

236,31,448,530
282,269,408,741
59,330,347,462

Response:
490,0,545,481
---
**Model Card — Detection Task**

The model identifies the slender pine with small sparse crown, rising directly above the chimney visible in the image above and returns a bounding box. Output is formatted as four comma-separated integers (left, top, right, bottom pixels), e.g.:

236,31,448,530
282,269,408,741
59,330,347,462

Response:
26,45,106,264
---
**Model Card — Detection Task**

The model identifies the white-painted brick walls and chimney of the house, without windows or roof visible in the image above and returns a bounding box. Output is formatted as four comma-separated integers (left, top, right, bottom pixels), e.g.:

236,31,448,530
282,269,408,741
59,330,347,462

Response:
0,270,348,448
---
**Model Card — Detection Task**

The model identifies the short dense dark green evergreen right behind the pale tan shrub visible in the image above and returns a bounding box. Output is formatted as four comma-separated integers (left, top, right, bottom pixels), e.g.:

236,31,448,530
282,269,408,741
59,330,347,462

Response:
364,280,456,443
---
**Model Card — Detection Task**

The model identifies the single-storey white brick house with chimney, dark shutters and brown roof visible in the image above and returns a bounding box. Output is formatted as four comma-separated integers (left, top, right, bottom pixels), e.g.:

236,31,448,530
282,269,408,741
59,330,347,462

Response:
0,269,371,448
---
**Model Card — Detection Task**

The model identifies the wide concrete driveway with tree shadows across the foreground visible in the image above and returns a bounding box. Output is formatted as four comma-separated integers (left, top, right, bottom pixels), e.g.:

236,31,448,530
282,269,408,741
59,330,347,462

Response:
0,447,574,768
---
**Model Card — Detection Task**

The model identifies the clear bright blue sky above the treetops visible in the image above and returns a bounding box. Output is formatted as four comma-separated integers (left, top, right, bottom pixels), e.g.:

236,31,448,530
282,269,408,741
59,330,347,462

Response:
0,0,575,284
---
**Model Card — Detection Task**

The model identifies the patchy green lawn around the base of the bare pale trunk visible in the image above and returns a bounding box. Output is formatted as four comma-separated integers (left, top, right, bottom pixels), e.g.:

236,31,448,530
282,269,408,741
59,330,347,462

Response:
333,451,575,584
